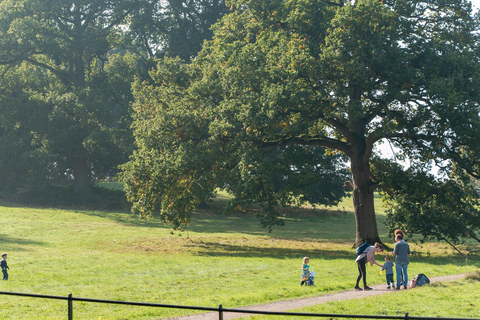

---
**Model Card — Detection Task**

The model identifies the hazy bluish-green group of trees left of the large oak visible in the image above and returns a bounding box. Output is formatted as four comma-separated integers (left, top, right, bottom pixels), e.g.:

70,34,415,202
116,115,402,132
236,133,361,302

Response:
0,0,226,205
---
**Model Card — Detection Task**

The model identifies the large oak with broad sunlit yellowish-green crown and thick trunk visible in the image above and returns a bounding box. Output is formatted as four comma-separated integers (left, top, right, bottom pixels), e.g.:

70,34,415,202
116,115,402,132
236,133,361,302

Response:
124,0,480,243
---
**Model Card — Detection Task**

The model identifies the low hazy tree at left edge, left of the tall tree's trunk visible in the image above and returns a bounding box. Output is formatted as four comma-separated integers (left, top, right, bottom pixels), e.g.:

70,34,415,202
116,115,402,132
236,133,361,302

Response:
0,64,58,199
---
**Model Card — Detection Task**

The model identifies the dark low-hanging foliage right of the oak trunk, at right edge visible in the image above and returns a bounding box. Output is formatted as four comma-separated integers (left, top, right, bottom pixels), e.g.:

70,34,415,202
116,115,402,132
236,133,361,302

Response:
375,161,480,250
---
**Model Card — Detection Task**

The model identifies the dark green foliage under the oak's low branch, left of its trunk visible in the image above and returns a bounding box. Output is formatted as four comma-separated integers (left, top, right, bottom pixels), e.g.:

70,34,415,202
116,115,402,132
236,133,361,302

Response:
224,145,349,231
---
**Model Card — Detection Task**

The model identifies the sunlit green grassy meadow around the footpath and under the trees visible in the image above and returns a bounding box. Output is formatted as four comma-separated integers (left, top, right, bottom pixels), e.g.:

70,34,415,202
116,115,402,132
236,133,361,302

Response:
0,194,480,319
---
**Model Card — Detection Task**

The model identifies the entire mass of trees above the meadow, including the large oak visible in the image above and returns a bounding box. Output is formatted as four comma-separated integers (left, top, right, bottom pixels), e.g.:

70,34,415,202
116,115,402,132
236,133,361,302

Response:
0,0,480,250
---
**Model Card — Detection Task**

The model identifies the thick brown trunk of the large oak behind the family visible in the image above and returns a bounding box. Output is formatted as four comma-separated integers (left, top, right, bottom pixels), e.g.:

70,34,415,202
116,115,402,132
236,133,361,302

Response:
350,151,380,246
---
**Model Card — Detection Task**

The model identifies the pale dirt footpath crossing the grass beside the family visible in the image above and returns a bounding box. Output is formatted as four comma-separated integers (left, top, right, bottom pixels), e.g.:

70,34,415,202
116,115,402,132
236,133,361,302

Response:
169,274,466,320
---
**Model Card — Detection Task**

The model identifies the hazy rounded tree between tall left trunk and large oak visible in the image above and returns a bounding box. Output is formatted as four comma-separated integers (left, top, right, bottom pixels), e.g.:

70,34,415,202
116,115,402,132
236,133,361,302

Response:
83,53,150,178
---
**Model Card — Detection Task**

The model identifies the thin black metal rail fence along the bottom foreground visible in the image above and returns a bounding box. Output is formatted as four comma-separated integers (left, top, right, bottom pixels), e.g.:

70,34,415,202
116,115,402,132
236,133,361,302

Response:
0,291,480,320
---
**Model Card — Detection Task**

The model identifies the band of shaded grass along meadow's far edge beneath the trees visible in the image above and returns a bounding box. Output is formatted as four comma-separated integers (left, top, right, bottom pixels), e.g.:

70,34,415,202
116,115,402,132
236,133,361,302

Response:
0,191,354,236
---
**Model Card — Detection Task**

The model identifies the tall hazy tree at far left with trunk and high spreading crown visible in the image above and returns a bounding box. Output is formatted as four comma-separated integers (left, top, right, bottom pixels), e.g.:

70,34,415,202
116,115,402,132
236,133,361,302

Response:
0,0,148,194
